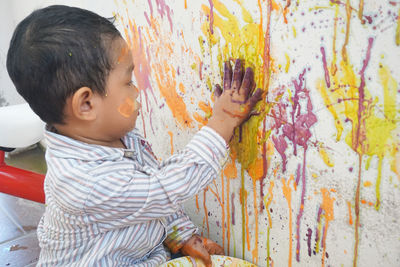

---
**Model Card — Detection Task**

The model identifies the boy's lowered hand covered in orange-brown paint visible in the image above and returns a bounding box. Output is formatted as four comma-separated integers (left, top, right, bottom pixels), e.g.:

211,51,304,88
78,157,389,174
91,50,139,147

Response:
181,235,224,267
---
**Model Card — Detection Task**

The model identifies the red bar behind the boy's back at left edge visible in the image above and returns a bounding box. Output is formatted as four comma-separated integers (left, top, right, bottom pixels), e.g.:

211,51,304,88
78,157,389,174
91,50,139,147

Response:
0,150,45,203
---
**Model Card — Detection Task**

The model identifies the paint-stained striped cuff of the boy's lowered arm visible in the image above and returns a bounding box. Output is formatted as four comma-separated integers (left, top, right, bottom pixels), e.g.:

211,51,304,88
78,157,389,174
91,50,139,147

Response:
164,208,198,254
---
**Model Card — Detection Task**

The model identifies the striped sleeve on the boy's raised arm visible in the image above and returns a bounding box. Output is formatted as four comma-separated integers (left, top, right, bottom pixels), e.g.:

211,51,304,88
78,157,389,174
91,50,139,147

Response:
84,127,228,227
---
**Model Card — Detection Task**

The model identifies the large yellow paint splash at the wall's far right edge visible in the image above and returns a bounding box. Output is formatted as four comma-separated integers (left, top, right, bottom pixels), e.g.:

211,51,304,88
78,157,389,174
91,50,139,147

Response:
317,45,399,214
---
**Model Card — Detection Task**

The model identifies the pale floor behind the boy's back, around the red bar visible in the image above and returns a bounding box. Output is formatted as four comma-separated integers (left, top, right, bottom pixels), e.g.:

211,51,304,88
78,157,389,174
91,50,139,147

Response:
0,146,46,267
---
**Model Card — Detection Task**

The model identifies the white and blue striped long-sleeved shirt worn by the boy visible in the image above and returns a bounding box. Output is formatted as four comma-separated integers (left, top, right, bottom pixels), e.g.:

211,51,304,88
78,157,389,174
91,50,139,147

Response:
37,127,227,266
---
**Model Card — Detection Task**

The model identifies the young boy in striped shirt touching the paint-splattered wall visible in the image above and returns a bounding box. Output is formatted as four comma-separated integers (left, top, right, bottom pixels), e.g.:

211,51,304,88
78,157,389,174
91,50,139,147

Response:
7,6,261,266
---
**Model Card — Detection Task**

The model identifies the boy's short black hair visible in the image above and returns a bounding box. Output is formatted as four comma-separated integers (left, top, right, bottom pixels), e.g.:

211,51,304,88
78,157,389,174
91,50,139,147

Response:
7,5,121,124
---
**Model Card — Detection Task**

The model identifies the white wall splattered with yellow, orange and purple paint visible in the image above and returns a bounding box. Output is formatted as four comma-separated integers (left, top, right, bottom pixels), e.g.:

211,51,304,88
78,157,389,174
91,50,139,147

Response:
115,0,400,266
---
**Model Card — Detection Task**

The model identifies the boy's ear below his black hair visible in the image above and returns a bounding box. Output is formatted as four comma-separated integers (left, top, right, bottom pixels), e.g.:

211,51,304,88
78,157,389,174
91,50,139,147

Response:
71,87,97,120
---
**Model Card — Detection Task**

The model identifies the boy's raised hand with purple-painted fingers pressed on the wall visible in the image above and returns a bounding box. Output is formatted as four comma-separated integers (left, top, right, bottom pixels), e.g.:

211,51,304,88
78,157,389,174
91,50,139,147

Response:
207,59,262,143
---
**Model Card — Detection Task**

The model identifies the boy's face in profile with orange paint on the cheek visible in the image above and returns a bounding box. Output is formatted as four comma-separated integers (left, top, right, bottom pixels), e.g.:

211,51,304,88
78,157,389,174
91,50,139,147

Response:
97,38,141,141
